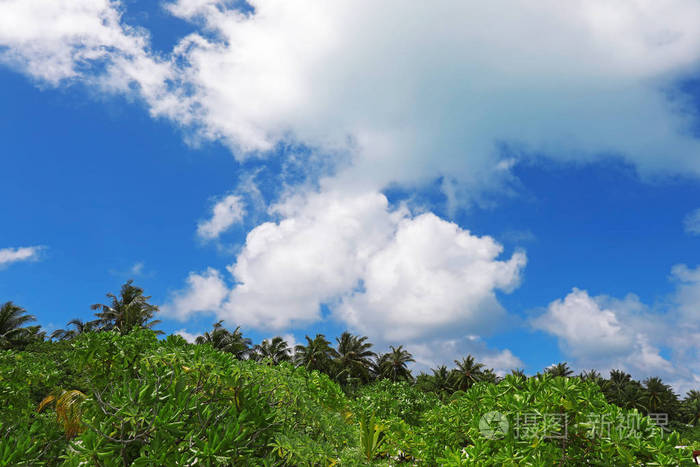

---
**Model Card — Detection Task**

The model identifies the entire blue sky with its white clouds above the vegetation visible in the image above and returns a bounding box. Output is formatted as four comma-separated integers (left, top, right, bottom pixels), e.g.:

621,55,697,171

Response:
0,0,700,391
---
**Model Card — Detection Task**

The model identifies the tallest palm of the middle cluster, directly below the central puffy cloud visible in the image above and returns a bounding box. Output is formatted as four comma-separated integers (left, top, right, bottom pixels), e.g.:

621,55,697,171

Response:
335,331,377,384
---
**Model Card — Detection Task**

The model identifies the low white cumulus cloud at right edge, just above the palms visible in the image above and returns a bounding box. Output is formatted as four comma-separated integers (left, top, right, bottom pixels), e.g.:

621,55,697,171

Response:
531,274,700,393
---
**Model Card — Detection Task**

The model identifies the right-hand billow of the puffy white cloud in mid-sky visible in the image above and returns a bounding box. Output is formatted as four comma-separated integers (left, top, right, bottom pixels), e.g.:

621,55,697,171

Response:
337,213,526,340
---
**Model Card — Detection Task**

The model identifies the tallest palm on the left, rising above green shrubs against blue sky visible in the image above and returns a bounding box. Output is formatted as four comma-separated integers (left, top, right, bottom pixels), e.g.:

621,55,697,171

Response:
91,280,163,335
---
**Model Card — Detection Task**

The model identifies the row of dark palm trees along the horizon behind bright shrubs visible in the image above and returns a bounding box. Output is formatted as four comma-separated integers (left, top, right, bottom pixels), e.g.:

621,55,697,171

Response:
0,281,700,431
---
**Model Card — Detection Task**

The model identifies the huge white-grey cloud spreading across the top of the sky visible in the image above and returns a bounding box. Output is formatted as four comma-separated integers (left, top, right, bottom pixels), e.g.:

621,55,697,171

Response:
0,0,700,199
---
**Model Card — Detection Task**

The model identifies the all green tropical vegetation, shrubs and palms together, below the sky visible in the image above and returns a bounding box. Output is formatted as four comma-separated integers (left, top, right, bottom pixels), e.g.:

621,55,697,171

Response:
0,281,700,466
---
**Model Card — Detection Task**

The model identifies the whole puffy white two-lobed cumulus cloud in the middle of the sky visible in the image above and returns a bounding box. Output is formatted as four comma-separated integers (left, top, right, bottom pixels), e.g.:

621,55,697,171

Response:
165,188,526,341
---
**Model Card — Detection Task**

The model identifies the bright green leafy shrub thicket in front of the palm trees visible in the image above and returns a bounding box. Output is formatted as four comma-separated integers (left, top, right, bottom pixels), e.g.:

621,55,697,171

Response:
0,330,692,466
